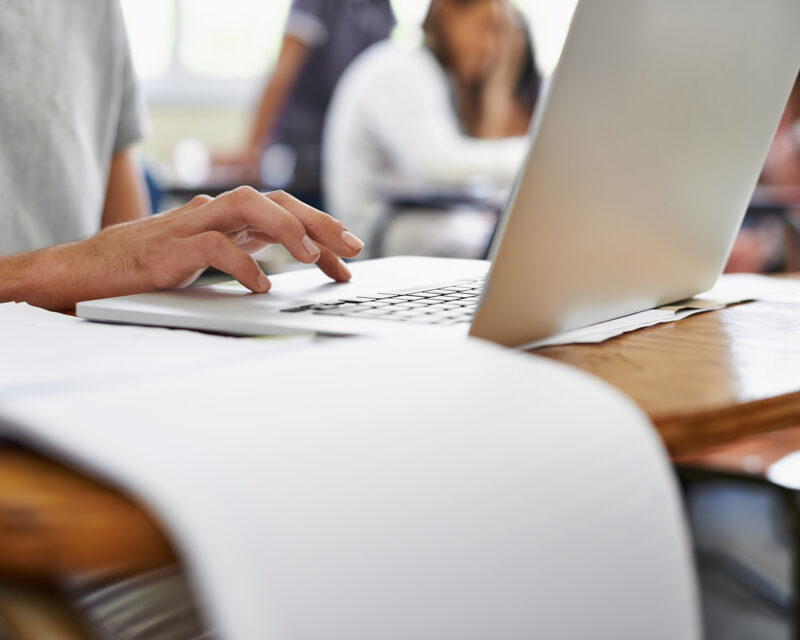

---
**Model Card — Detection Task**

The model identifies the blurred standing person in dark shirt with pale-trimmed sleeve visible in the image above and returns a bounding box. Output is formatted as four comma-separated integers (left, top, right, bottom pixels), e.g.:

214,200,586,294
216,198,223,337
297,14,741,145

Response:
216,0,396,206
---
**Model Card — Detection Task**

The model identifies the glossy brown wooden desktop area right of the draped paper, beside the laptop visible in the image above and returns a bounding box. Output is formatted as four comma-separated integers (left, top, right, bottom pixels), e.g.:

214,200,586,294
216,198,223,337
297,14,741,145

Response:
536,302,800,456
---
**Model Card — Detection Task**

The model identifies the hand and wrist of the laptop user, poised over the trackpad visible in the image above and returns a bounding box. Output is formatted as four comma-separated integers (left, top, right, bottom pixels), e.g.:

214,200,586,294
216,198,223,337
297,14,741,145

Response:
25,187,364,309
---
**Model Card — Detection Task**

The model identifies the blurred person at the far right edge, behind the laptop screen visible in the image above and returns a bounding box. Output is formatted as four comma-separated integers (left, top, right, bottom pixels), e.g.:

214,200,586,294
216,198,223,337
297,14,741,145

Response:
726,74,800,272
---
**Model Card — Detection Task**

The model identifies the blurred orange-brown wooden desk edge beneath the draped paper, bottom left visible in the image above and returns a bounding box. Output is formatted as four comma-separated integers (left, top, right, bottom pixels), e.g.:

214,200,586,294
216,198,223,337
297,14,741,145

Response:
0,448,175,580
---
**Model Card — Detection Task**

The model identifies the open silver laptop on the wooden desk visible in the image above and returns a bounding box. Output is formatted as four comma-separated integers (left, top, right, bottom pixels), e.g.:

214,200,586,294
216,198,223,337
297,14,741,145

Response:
77,0,800,346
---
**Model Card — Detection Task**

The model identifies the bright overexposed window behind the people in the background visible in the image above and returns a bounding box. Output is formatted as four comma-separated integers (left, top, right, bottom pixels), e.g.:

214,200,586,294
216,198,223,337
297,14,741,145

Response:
122,0,576,105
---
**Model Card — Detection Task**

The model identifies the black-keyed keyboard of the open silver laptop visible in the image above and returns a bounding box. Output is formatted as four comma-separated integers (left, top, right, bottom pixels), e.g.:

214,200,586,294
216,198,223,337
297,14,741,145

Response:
281,278,484,325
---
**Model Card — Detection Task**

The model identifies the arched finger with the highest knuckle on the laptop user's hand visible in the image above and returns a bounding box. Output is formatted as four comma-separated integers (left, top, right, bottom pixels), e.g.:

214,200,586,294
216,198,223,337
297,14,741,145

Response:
185,187,321,264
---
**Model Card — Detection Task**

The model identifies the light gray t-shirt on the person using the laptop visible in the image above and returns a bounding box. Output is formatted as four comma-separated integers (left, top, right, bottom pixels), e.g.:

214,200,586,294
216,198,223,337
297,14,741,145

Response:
0,0,143,255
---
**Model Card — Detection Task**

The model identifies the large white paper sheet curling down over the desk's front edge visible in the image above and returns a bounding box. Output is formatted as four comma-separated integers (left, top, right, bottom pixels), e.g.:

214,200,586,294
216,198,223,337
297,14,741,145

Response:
0,336,700,640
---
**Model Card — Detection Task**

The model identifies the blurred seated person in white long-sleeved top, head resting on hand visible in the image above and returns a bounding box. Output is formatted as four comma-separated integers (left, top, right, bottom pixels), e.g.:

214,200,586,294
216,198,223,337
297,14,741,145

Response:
323,0,540,257
